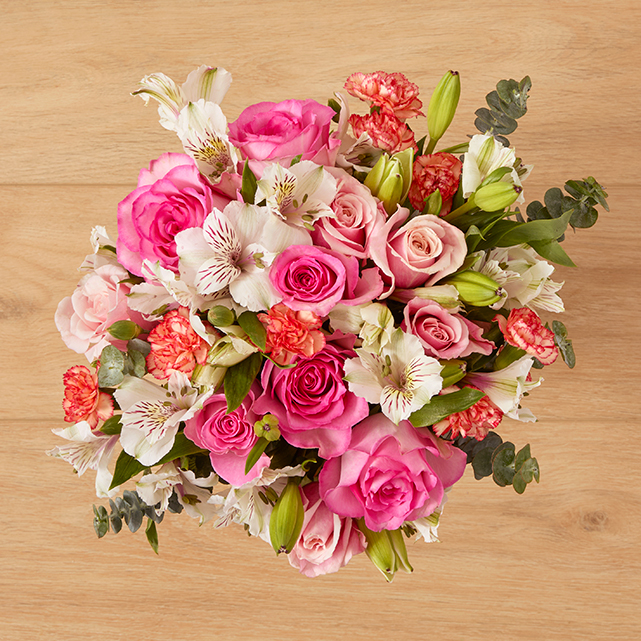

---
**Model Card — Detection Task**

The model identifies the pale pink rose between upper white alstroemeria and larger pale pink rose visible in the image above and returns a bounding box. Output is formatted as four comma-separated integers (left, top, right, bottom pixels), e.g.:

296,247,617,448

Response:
312,167,386,259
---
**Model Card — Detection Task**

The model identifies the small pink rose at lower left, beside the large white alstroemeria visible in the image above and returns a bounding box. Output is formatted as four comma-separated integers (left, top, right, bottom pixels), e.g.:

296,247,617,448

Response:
185,383,269,487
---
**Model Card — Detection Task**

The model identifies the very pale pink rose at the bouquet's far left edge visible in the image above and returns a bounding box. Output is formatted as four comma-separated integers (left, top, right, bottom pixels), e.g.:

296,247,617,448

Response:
55,264,133,362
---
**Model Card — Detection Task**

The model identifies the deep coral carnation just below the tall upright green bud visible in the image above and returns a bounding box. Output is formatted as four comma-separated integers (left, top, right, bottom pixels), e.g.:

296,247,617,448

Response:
409,152,463,215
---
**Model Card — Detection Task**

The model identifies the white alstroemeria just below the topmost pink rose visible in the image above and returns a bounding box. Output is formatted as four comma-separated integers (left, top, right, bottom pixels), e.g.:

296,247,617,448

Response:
256,160,337,229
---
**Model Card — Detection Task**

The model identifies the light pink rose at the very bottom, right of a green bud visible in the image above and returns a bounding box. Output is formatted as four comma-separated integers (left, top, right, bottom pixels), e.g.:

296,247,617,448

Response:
287,483,365,577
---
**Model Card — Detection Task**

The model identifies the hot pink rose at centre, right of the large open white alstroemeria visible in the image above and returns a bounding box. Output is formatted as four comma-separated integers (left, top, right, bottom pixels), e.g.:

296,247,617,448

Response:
269,245,383,316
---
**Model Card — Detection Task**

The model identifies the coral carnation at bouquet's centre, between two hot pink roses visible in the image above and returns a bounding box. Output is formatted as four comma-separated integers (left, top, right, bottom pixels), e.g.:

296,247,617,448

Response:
258,303,325,365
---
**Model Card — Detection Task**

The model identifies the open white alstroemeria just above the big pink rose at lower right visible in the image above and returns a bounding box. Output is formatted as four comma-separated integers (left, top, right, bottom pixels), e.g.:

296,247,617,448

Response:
344,329,443,425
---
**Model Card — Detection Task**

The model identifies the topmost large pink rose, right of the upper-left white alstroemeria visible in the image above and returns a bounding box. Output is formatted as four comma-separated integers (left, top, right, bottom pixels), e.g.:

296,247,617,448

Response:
229,100,340,166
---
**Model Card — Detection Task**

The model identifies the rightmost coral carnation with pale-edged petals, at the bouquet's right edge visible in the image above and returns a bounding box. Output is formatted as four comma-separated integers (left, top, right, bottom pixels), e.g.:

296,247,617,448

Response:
494,307,559,365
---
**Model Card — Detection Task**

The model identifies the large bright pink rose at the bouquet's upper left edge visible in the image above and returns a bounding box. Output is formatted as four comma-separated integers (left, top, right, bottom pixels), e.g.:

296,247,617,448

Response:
116,153,235,276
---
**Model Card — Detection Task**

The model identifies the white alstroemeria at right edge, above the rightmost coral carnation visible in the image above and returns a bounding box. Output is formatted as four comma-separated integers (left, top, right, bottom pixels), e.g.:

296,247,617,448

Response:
472,245,564,314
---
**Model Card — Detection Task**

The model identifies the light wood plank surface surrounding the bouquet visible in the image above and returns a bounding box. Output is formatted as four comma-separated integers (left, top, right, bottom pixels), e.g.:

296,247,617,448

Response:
0,0,641,641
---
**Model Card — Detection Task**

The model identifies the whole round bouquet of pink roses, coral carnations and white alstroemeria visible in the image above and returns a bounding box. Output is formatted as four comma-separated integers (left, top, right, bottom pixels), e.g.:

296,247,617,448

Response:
49,66,607,580
